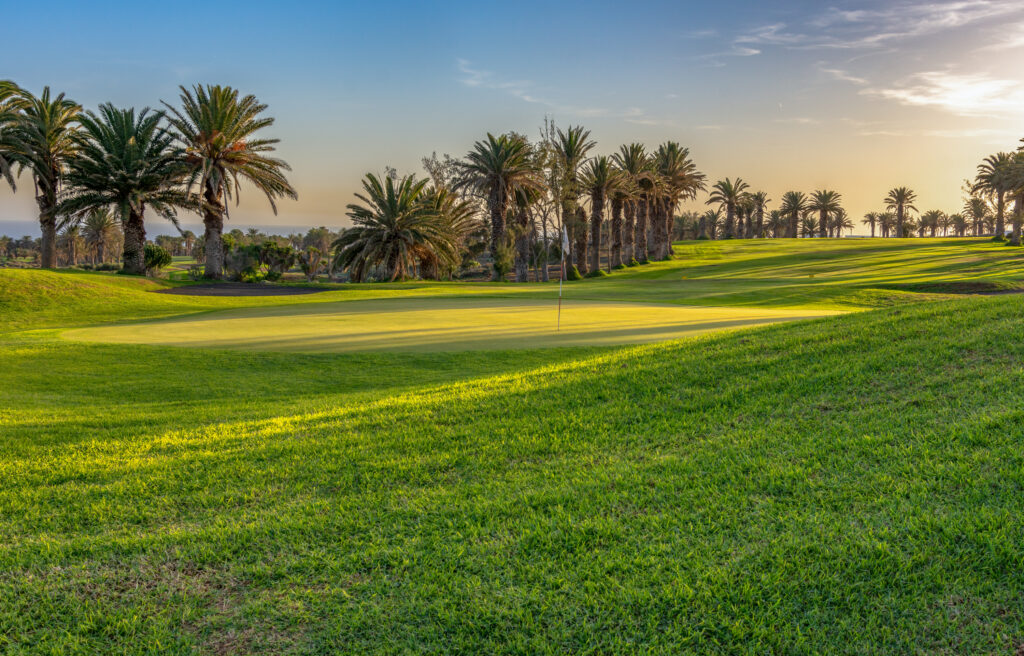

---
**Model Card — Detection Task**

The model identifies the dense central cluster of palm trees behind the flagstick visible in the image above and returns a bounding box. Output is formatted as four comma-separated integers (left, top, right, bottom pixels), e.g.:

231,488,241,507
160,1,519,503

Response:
334,123,705,281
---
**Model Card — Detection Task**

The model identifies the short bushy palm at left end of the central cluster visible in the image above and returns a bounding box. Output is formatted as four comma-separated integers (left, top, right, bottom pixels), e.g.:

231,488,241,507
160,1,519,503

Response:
332,173,458,282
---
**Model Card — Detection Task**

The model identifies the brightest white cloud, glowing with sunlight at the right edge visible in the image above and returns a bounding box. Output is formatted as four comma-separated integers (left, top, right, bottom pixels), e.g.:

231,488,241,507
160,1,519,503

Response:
860,71,1024,117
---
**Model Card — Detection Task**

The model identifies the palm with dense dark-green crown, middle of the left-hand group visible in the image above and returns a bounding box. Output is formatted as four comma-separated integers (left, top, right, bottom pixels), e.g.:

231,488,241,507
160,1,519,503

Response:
59,103,196,275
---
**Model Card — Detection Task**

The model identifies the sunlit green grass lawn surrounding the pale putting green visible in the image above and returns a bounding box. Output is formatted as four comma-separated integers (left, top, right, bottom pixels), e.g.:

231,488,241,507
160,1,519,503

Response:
0,239,1024,654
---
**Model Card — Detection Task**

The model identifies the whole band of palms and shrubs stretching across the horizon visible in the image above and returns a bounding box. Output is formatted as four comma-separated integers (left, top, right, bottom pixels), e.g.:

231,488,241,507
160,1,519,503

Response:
0,82,1024,282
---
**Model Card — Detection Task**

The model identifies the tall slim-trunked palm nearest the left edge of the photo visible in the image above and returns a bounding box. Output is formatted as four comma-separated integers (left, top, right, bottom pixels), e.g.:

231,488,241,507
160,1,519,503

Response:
4,83,82,268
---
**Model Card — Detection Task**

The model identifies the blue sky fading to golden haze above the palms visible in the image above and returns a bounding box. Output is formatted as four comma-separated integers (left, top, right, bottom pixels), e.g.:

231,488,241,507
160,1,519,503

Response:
0,0,1024,234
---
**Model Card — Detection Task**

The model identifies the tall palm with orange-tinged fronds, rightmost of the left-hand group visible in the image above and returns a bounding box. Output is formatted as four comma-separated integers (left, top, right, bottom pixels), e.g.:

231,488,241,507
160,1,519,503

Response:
164,85,298,278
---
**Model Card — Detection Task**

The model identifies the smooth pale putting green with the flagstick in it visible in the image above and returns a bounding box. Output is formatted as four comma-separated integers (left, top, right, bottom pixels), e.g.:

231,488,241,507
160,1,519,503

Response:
63,298,835,352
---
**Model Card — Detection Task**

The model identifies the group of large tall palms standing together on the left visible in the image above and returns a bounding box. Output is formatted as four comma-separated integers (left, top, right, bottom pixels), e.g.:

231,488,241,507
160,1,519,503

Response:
0,81,296,277
